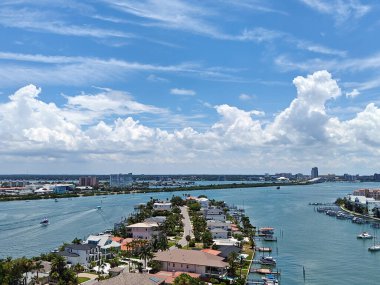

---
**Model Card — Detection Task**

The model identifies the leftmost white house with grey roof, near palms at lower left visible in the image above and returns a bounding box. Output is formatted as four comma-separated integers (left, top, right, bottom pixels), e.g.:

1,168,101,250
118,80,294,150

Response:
58,244,101,266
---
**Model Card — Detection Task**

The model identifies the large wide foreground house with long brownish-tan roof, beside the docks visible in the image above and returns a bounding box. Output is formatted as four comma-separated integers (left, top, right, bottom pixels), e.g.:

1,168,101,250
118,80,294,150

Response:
153,249,228,277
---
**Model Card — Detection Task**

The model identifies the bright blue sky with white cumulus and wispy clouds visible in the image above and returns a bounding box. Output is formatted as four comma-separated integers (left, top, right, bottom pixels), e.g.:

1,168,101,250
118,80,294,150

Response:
0,0,380,174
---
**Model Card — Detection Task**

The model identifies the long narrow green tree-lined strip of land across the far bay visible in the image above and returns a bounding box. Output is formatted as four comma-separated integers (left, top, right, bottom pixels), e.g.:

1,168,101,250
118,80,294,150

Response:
0,182,312,202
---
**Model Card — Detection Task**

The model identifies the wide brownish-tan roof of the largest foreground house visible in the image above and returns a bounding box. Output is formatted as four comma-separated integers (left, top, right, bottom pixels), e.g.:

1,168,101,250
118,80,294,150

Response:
153,249,228,268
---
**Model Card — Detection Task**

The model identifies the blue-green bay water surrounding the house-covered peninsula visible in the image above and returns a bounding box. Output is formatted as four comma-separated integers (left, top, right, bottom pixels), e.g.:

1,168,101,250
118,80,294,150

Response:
0,183,380,285
